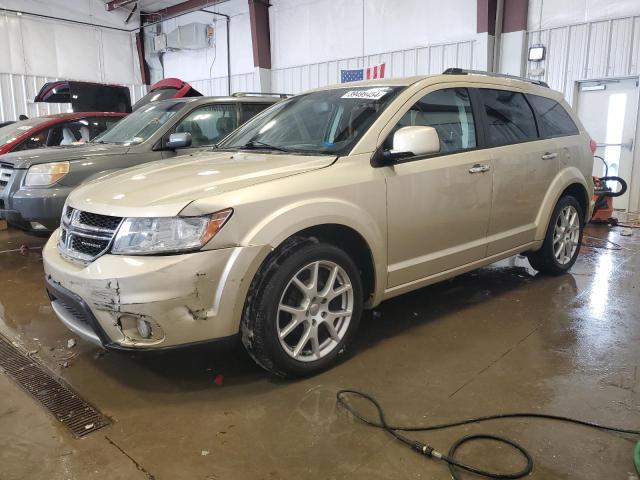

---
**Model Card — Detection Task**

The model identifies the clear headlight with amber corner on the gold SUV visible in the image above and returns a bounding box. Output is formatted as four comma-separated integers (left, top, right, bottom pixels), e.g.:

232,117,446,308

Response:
111,208,233,255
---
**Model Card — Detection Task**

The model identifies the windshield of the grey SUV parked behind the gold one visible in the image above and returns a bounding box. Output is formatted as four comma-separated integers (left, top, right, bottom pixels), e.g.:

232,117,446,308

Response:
93,102,185,145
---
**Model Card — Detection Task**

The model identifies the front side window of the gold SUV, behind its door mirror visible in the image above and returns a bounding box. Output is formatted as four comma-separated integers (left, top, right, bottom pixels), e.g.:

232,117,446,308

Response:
384,88,476,153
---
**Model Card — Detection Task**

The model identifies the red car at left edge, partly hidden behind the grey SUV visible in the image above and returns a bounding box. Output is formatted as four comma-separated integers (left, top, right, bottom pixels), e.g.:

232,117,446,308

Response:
0,112,127,155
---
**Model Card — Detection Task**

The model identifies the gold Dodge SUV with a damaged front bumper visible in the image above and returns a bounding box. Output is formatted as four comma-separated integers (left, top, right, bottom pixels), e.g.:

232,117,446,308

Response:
44,70,593,376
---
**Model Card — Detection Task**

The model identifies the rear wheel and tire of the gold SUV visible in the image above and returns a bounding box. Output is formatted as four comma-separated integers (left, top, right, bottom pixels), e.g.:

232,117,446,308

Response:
527,195,584,275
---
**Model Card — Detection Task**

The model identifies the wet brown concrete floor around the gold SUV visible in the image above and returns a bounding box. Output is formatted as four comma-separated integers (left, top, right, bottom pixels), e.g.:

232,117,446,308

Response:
0,227,640,480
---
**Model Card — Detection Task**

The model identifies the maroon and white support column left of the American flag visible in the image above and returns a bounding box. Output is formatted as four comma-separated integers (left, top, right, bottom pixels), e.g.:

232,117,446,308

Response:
248,0,271,92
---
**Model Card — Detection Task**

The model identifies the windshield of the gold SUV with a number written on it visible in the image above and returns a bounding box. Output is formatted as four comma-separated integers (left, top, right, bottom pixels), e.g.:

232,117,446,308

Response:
217,87,402,155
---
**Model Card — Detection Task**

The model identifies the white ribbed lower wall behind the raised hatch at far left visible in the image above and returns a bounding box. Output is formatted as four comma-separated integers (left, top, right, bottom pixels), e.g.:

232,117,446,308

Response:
0,73,147,121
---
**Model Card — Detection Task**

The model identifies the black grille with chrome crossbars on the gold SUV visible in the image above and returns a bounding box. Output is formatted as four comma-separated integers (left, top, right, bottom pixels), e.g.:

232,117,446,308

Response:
58,207,122,262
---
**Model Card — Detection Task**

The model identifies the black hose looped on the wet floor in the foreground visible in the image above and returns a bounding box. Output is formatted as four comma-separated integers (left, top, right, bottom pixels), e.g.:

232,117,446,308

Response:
336,390,640,480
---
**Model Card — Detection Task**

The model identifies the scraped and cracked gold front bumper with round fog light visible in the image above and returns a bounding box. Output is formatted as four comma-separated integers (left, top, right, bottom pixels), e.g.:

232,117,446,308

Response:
43,231,268,350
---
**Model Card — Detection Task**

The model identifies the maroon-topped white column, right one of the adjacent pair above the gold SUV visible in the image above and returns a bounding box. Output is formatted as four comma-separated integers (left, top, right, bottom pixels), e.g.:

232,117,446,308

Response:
500,0,529,77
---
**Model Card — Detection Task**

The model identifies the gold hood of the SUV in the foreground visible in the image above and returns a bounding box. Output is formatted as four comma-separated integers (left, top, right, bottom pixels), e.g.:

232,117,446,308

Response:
68,151,336,217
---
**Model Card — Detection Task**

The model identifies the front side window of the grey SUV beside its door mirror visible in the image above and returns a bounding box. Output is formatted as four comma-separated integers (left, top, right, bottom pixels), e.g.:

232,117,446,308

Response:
175,103,237,147
